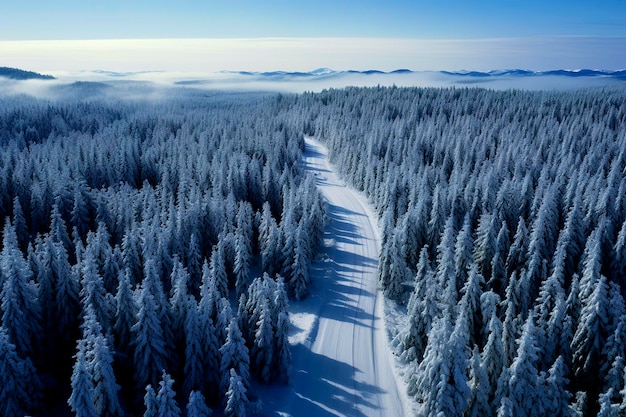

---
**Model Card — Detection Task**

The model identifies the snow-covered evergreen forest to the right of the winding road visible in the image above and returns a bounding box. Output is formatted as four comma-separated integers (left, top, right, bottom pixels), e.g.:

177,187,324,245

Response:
289,88,626,416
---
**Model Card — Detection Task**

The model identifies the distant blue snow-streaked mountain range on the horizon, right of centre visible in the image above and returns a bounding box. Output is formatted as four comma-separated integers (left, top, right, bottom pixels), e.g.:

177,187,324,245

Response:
223,68,626,80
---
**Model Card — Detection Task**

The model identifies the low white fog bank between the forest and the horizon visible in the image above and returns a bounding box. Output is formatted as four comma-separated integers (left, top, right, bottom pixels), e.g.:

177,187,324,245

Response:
0,70,626,99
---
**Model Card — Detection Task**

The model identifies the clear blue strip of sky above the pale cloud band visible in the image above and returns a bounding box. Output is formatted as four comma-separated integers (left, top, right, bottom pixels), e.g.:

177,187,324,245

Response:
0,0,626,40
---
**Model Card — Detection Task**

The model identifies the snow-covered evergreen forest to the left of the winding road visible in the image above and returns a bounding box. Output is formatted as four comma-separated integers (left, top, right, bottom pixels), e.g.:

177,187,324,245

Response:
0,94,326,417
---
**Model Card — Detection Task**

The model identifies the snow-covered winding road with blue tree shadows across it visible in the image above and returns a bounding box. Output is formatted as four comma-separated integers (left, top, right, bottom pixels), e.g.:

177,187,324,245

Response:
261,139,409,417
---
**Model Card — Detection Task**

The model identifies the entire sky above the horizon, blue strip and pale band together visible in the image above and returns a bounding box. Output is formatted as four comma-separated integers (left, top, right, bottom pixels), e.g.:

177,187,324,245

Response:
0,0,626,71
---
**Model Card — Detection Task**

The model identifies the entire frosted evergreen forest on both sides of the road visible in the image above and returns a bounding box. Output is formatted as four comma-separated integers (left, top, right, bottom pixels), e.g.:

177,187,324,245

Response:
0,84,626,416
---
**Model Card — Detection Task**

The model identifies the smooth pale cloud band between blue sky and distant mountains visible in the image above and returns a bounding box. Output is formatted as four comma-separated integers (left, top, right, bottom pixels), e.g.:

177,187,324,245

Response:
0,37,626,74
